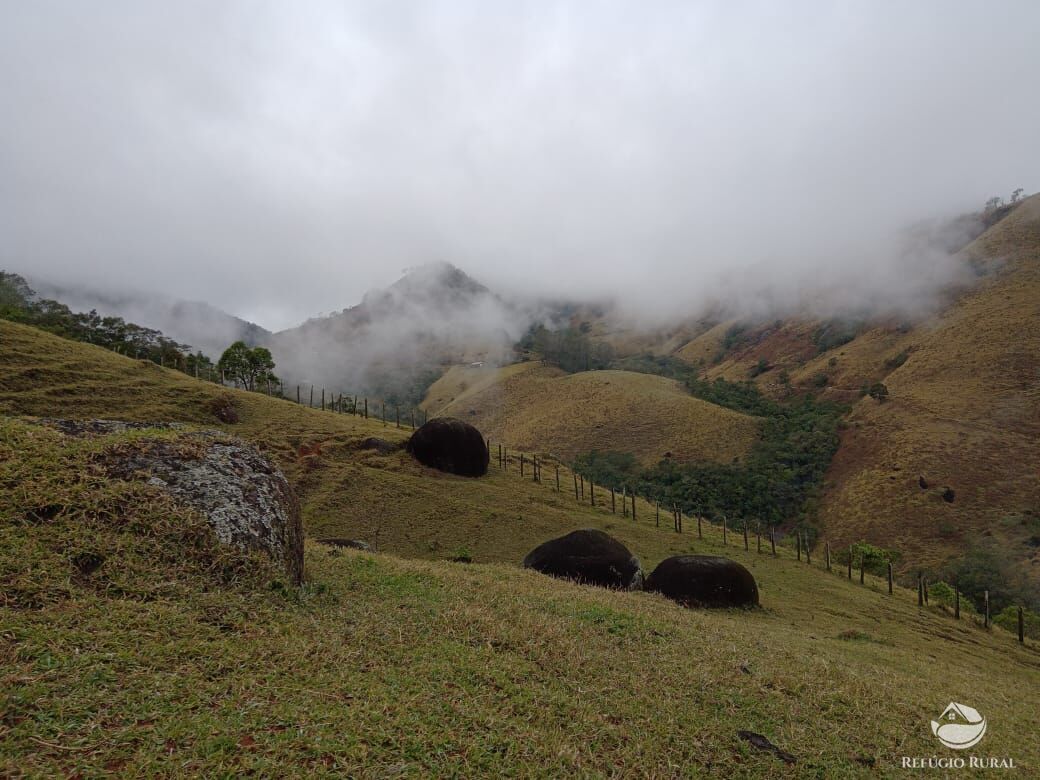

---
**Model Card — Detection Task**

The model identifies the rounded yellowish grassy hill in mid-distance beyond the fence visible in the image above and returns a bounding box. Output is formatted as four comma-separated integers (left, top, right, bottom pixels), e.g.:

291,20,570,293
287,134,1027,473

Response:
426,363,758,465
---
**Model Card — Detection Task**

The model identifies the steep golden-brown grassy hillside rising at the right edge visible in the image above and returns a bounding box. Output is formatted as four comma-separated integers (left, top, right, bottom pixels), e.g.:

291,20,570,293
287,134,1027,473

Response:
823,198,1040,577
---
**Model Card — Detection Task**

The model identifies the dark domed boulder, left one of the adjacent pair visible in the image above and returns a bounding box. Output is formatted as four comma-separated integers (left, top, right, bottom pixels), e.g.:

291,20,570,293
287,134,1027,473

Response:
523,528,643,591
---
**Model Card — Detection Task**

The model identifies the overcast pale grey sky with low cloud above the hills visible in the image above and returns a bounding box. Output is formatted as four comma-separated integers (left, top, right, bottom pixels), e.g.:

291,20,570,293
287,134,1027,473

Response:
0,0,1040,329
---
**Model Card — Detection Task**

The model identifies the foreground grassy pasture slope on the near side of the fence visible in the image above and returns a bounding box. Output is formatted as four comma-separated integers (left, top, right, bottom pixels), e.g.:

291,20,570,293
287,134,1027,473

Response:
6,323,1040,777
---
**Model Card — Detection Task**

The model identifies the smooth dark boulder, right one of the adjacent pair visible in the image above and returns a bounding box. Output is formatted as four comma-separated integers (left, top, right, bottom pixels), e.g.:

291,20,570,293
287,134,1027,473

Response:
646,555,758,607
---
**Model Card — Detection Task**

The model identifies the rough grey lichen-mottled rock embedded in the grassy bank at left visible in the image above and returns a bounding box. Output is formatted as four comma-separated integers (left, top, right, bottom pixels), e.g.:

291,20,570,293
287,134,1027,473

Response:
45,420,304,583
